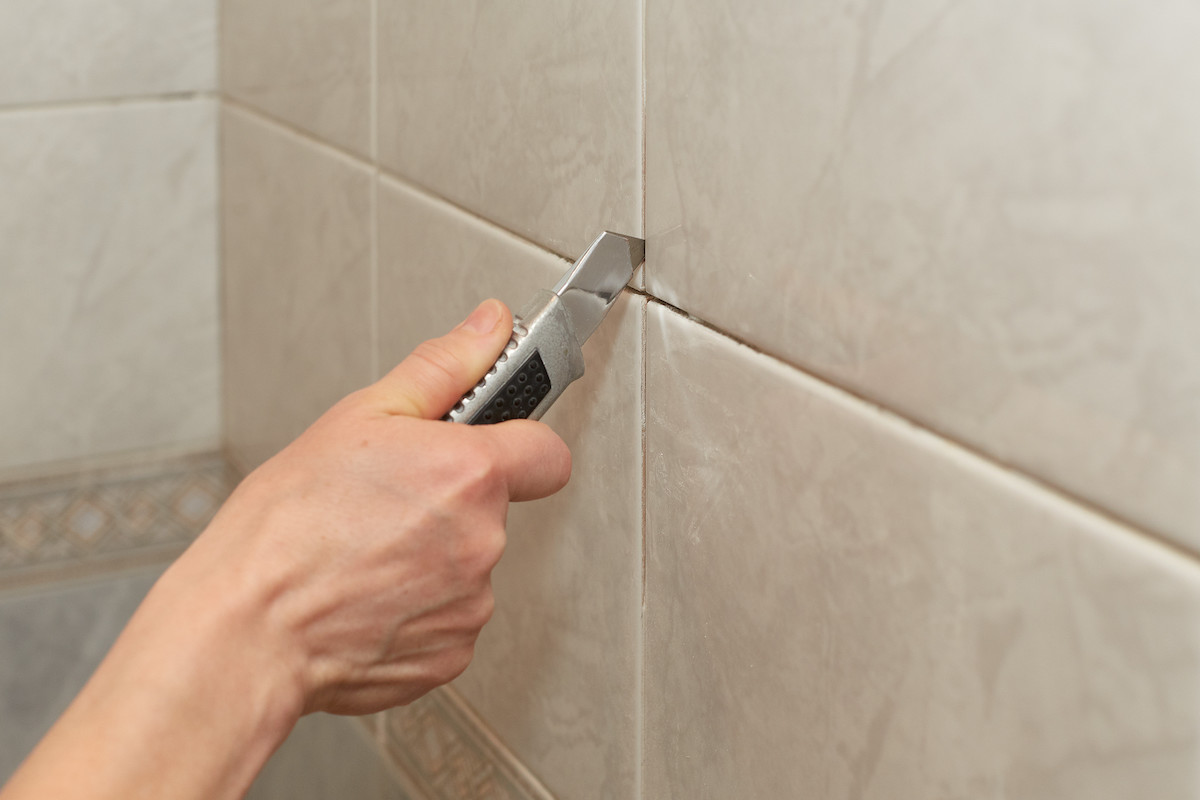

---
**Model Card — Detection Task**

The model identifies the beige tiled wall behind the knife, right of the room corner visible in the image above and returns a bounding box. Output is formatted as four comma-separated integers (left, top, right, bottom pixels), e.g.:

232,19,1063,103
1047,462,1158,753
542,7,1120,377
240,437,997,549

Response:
221,0,1200,800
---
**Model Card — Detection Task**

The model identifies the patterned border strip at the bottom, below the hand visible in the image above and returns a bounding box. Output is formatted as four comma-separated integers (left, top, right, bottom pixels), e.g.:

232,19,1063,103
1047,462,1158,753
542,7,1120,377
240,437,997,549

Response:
382,687,553,800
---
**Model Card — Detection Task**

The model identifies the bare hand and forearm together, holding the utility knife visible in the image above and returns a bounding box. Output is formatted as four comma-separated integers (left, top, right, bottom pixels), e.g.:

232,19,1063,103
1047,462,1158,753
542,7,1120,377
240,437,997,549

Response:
0,300,570,800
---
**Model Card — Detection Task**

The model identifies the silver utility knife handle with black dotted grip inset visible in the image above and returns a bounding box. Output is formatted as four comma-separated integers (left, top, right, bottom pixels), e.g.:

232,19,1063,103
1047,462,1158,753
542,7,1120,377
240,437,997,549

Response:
443,291,583,425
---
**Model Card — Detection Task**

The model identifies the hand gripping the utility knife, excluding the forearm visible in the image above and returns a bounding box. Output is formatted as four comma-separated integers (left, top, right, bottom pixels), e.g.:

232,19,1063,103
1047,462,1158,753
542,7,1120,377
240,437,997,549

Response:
162,301,570,714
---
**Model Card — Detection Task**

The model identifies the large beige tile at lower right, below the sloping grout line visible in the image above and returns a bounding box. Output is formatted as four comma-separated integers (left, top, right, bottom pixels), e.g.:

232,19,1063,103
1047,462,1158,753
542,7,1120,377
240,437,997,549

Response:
643,305,1200,800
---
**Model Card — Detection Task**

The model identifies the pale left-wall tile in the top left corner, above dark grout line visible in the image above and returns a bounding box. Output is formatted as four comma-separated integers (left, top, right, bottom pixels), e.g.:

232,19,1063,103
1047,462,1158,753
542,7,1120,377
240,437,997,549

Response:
0,0,217,106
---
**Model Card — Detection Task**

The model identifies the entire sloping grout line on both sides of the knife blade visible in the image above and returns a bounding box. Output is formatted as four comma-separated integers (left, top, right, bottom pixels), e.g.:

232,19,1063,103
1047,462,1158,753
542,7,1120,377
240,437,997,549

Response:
220,92,1200,567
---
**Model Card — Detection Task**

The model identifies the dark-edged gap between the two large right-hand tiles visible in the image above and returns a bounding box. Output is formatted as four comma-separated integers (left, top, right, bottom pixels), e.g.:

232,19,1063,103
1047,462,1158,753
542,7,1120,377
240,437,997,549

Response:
643,288,1200,578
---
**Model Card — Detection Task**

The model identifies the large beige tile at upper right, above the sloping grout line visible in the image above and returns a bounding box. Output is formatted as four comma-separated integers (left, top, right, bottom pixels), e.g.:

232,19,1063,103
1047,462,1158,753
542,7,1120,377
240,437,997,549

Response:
647,0,1200,546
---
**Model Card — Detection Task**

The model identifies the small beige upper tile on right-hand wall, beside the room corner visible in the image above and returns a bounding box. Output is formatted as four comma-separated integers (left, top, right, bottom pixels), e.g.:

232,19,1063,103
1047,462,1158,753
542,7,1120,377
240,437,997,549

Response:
221,0,371,155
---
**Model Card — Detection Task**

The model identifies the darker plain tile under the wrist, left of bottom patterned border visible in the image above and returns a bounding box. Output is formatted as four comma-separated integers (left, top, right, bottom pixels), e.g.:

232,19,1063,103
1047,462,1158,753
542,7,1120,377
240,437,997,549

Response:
246,714,408,800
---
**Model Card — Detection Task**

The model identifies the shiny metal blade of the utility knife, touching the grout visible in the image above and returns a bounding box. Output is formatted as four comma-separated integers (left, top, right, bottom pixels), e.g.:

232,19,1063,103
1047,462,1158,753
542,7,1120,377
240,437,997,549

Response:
553,230,646,344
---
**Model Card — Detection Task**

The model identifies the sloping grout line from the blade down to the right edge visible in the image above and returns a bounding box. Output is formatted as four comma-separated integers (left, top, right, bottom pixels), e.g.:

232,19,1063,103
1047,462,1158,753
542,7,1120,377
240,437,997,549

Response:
643,287,1200,569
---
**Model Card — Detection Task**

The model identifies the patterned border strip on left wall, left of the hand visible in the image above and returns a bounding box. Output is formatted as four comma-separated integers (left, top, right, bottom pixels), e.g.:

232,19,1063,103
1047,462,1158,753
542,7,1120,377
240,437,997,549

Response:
0,455,238,587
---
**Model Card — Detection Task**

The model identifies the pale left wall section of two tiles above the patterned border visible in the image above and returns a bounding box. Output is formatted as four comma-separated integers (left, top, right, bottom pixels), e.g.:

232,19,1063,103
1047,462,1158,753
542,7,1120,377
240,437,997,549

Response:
0,0,220,480
